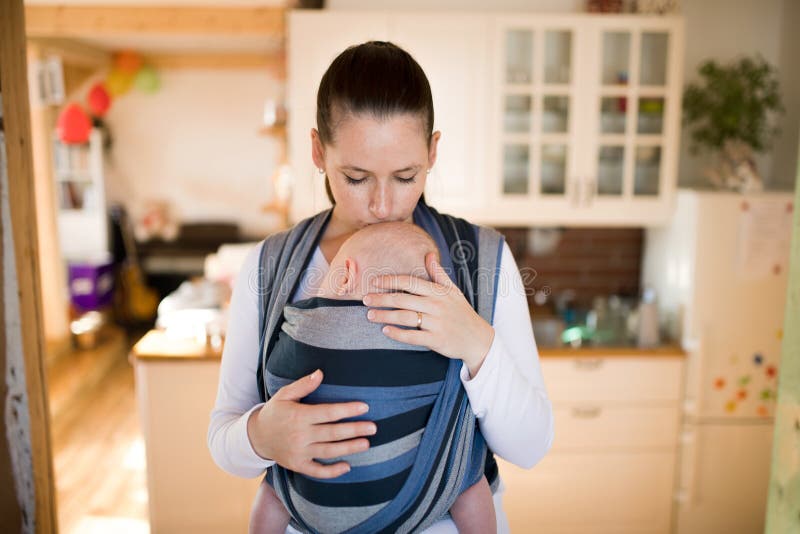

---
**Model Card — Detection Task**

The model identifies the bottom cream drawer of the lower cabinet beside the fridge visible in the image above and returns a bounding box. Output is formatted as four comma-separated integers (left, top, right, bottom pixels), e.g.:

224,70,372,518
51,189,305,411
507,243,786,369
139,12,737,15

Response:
498,452,675,534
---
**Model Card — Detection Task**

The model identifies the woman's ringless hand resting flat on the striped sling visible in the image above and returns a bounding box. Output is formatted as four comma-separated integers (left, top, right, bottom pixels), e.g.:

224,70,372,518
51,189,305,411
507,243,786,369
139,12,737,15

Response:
247,370,376,478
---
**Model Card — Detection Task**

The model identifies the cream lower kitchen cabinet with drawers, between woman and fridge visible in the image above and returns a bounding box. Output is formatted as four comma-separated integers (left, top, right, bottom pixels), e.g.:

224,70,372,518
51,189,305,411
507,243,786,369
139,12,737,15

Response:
498,354,683,534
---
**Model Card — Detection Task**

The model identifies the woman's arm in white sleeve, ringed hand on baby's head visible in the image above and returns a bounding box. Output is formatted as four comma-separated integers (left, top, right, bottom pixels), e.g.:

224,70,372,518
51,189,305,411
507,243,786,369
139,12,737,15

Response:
364,243,553,467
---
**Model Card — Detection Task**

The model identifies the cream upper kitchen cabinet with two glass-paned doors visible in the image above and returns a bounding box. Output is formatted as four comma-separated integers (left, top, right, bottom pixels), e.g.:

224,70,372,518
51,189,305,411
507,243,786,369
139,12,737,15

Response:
487,15,683,226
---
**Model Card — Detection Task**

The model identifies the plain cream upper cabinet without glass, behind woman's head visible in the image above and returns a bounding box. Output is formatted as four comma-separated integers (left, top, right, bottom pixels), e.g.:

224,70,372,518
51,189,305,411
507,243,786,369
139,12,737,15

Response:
289,11,490,221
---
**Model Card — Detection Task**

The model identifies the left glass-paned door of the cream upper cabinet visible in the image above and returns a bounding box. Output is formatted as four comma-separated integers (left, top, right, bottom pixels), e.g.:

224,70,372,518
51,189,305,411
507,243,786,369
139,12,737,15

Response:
499,26,574,203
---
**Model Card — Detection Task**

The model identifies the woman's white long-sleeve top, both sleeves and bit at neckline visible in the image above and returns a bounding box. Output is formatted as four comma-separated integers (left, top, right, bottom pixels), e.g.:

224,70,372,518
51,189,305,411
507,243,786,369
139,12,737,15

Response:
208,243,553,478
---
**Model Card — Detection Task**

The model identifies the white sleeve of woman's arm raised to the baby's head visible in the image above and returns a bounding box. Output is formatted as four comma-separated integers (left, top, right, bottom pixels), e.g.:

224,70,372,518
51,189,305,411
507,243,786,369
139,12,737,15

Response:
461,243,553,468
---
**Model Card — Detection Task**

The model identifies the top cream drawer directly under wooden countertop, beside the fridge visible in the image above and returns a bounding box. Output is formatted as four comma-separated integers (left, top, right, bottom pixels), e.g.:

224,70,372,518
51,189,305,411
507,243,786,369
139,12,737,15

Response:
541,357,683,403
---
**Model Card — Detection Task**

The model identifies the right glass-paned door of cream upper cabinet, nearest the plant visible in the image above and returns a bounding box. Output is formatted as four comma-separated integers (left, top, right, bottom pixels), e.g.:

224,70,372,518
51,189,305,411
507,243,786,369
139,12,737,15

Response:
593,28,670,198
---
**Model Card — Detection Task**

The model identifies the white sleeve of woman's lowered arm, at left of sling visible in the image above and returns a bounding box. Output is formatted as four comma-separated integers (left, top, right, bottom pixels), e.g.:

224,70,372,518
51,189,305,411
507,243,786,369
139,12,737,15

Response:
208,244,275,478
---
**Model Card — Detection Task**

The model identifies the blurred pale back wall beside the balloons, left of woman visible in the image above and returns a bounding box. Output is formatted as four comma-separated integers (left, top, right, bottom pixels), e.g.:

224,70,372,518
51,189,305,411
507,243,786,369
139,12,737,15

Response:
106,70,282,235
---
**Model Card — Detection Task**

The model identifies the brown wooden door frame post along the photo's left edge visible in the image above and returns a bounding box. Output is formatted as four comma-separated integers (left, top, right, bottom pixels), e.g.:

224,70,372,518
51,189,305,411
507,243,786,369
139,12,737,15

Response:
0,0,57,533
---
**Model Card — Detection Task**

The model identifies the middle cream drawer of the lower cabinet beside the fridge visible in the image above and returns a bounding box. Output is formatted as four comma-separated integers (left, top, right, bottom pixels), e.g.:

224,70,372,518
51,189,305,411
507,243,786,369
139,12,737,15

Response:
552,402,680,452
